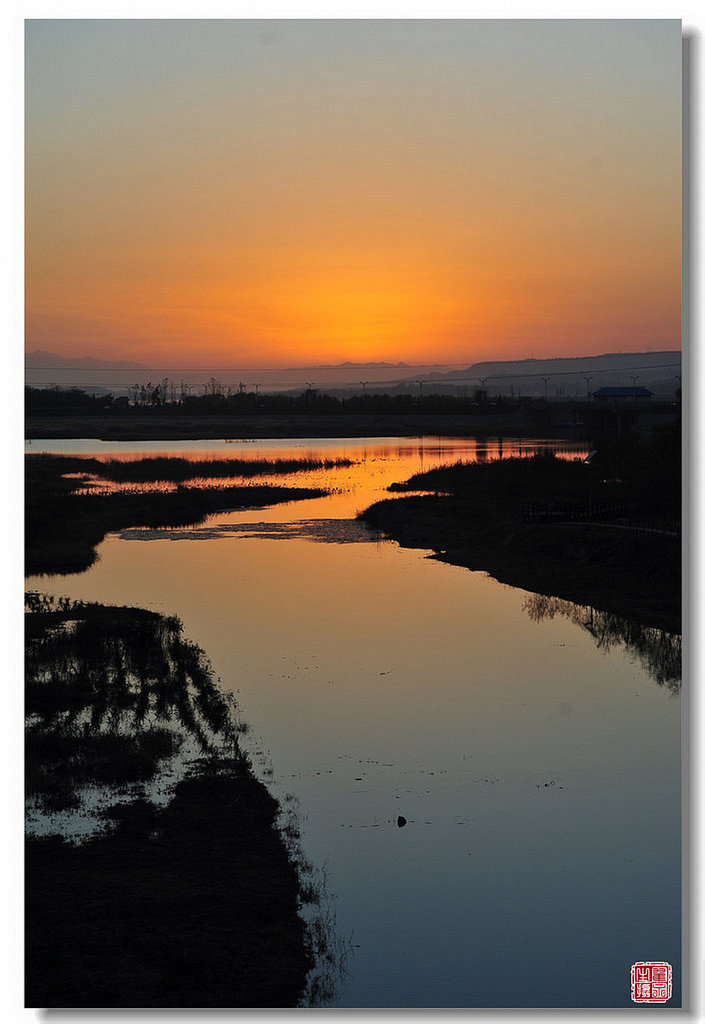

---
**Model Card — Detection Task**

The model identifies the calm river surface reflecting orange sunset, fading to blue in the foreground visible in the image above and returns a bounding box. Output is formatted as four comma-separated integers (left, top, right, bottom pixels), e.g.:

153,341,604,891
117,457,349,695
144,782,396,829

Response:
28,438,680,1008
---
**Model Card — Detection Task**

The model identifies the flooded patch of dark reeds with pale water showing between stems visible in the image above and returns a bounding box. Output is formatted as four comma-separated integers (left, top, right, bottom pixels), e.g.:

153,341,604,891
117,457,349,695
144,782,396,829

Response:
26,594,241,810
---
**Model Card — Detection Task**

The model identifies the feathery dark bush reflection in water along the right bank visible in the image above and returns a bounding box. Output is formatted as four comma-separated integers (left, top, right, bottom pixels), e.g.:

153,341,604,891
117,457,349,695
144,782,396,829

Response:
524,594,681,693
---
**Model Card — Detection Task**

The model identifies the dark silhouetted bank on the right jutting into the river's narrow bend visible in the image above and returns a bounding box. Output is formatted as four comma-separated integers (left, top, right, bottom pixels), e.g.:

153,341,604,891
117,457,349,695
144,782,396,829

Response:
362,448,680,632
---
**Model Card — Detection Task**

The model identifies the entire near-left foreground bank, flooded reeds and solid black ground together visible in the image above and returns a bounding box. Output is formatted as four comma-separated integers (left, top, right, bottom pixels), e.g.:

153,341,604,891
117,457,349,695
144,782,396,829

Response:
26,596,327,1008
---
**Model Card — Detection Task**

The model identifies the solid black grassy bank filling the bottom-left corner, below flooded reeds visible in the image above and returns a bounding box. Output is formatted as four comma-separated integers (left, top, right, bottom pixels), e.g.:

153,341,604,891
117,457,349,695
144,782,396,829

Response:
26,761,313,1009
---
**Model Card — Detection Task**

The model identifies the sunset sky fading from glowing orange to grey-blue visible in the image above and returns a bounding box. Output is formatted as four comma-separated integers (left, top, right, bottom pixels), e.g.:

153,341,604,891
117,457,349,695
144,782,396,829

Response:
26,18,681,368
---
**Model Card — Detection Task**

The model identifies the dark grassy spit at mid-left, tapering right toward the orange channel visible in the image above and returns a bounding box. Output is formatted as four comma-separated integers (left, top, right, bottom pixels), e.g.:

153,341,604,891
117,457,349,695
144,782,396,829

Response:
25,456,326,574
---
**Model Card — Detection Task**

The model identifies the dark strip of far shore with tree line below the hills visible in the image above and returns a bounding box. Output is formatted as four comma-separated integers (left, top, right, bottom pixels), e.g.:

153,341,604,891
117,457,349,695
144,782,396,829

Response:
25,378,679,440
